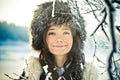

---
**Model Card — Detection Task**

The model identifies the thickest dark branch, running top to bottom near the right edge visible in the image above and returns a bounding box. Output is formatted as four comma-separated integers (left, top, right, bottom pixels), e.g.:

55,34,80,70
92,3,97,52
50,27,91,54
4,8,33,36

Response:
104,0,116,80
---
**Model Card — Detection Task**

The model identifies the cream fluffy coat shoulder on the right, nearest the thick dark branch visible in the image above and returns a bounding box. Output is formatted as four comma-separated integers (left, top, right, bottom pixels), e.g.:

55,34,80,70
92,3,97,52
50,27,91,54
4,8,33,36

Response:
84,63,98,80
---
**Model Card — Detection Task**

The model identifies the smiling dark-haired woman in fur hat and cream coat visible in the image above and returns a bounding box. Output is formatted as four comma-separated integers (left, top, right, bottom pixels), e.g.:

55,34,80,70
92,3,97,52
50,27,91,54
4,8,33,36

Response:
20,1,96,80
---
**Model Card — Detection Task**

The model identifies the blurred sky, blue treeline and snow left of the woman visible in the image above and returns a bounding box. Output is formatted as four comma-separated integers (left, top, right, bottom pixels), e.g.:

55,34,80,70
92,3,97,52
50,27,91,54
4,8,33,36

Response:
0,0,44,80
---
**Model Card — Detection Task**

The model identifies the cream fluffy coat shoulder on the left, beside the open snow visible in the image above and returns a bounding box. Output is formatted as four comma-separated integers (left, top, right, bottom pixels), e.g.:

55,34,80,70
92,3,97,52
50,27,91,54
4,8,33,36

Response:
25,56,42,80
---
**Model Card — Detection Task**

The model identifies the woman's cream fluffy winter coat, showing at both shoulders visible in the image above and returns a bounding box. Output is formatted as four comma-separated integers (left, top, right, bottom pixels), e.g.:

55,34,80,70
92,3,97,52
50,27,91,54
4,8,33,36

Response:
22,56,98,80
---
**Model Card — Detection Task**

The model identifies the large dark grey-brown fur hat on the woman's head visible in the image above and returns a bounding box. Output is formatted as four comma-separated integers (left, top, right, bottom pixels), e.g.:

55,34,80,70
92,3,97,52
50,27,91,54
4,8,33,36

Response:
30,1,86,50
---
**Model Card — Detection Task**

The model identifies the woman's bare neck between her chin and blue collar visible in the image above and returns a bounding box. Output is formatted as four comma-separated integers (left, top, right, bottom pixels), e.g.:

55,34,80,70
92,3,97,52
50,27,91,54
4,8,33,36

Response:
55,56,67,68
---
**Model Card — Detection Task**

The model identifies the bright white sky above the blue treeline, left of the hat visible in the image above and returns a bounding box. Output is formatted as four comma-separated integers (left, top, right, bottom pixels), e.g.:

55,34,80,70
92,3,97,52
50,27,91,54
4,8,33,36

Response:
0,0,51,26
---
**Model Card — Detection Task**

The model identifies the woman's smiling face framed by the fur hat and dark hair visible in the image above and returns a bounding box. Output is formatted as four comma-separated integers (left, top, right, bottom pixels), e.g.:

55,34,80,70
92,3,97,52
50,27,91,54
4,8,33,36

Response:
46,25,73,56
